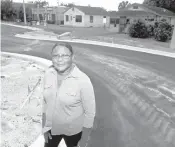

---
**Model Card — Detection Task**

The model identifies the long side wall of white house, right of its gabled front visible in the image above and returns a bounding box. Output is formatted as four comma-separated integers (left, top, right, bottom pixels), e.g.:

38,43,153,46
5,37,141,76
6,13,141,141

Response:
85,15,110,27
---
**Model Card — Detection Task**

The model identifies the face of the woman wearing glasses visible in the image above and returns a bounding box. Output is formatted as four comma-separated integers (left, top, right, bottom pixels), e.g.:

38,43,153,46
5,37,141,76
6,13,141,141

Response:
52,46,73,73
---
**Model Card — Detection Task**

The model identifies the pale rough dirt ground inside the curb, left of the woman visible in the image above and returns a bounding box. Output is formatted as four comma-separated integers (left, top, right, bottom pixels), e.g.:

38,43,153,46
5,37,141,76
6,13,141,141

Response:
1,56,44,147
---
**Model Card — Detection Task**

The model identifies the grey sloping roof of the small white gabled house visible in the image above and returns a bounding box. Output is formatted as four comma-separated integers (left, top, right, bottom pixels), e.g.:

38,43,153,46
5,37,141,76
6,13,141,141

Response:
64,6,109,16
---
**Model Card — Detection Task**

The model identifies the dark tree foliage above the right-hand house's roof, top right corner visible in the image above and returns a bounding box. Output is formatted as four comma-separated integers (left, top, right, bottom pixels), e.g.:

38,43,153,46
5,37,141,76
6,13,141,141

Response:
143,0,175,12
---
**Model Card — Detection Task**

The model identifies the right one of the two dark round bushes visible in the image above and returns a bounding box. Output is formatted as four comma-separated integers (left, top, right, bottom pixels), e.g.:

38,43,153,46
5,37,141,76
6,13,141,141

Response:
154,21,173,42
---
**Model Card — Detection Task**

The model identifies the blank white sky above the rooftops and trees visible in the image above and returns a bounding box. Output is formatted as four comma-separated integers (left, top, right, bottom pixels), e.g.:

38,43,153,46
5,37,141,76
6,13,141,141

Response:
13,0,143,10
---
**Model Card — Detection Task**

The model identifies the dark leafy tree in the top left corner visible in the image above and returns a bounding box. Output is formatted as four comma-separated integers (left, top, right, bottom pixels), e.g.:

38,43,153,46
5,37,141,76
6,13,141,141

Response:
1,0,16,20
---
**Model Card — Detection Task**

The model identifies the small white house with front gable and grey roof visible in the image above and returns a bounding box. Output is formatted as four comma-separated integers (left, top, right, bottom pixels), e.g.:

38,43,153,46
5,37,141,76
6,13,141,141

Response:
64,6,110,27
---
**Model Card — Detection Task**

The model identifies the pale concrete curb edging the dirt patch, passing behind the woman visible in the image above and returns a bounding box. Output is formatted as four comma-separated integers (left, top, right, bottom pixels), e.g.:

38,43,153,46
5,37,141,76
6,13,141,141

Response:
0,52,66,147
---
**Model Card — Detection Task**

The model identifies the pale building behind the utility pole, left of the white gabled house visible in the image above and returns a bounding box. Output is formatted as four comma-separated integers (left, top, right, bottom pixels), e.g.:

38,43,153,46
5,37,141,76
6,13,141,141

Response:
32,6,68,24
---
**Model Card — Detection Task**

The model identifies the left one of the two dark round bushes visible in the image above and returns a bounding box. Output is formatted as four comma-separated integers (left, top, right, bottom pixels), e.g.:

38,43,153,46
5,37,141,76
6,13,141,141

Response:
129,20,149,38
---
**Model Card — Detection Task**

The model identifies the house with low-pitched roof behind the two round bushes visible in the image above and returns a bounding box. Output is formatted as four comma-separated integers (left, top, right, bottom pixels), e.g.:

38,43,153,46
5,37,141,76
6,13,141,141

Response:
109,3,175,32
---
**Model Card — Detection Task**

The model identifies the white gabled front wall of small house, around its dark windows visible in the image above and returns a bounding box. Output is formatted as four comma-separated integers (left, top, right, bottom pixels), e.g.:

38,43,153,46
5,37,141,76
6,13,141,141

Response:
64,8,85,27
